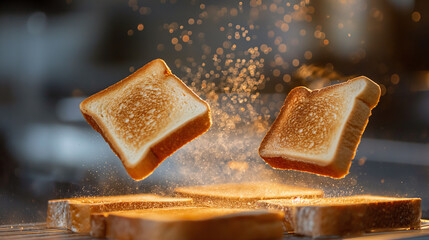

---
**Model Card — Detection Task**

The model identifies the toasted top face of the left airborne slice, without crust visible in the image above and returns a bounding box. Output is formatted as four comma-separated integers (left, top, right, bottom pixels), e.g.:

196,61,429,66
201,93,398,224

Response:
84,62,208,167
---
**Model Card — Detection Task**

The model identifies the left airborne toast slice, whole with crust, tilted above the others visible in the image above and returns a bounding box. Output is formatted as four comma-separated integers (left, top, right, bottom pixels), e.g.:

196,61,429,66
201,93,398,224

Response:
80,59,211,180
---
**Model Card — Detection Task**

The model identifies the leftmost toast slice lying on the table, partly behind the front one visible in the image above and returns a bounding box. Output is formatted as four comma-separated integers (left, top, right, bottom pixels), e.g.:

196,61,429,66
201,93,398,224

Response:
47,194,192,233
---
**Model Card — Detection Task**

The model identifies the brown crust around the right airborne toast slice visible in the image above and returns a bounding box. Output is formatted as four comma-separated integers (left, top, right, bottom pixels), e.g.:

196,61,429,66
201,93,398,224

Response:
259,76,381,178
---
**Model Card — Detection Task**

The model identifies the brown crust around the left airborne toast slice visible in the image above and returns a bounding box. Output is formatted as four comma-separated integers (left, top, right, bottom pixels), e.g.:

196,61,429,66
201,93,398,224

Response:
80,59,212,180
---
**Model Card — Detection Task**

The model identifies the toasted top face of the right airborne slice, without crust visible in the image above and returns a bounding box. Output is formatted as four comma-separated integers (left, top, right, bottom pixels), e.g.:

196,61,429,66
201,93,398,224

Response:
260,78,369,166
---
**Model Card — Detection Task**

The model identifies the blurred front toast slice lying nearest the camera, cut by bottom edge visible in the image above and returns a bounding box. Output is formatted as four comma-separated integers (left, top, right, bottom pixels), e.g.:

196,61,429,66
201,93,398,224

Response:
106,207,283,240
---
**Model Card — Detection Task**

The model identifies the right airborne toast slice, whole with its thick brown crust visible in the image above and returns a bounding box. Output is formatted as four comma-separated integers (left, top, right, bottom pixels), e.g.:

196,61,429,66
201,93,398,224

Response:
259,77,380,178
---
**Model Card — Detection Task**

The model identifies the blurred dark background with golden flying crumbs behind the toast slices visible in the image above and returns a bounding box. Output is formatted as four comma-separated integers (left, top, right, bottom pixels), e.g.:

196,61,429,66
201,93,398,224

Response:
0,0,429,224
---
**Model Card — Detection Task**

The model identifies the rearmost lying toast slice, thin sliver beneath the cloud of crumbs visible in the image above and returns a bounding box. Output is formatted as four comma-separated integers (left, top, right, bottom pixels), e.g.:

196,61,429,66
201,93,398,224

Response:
174,182,323,208
